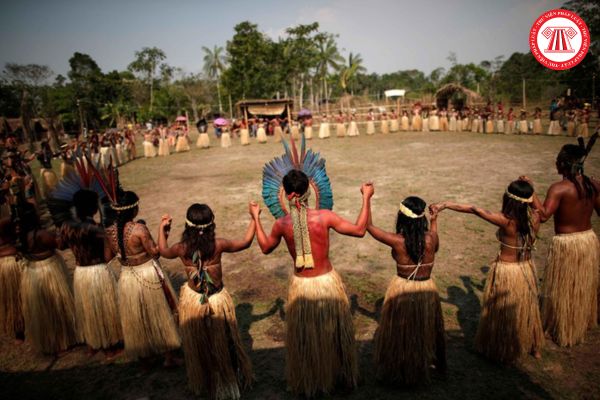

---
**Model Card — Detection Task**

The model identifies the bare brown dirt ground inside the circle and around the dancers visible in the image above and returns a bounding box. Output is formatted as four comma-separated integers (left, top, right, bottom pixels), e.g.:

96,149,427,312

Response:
0,132,600,400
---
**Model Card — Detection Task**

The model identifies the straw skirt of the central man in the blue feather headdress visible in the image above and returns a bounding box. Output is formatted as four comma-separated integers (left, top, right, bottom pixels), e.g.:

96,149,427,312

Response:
286,270,358,397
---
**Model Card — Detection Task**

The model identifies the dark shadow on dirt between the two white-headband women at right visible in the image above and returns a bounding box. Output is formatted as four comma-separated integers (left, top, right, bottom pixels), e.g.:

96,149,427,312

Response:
441,275,483,345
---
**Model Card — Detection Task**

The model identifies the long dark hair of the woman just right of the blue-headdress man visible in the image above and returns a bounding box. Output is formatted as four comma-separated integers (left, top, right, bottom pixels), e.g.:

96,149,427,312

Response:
396,196,429,264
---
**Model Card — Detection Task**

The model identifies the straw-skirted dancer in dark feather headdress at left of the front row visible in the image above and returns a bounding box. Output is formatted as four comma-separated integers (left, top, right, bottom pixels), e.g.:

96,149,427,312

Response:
54,187,123,350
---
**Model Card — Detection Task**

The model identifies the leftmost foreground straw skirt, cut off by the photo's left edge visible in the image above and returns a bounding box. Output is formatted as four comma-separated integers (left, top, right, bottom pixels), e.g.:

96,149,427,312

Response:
0,256,25,338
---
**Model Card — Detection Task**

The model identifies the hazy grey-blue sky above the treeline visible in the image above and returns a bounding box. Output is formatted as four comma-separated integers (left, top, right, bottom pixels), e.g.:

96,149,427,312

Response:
0,0,564,79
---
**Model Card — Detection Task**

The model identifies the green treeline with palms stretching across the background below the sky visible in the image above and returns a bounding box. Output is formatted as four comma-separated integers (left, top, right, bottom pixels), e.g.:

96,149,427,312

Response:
0,0,600,137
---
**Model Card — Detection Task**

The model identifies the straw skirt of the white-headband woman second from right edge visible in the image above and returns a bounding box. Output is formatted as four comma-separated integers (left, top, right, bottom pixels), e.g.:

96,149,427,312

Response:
475,261,544,364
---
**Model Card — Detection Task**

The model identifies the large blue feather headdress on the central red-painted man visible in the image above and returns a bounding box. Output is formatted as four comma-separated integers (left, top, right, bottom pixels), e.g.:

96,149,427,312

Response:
262,134,333,218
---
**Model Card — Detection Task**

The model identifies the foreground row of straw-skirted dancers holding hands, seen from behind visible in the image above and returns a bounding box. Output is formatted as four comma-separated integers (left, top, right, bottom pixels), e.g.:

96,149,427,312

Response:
0,123,600,399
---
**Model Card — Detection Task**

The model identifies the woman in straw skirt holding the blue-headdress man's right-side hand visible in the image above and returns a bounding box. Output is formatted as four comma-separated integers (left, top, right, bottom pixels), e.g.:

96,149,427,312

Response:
368,197,446,385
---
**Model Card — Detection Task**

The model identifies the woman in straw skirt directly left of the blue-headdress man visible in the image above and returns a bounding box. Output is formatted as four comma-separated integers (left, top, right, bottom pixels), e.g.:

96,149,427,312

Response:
158,204,253,399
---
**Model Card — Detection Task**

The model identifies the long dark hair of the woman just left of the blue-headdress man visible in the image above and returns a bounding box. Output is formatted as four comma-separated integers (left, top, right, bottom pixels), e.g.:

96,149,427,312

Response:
181,203,215,261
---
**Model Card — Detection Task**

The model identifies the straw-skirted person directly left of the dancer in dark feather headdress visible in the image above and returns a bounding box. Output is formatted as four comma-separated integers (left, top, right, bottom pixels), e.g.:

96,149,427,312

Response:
20,203,77,354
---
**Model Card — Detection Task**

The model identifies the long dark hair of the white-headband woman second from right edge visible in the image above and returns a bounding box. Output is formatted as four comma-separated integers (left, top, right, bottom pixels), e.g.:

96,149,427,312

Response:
502,180,535,258
